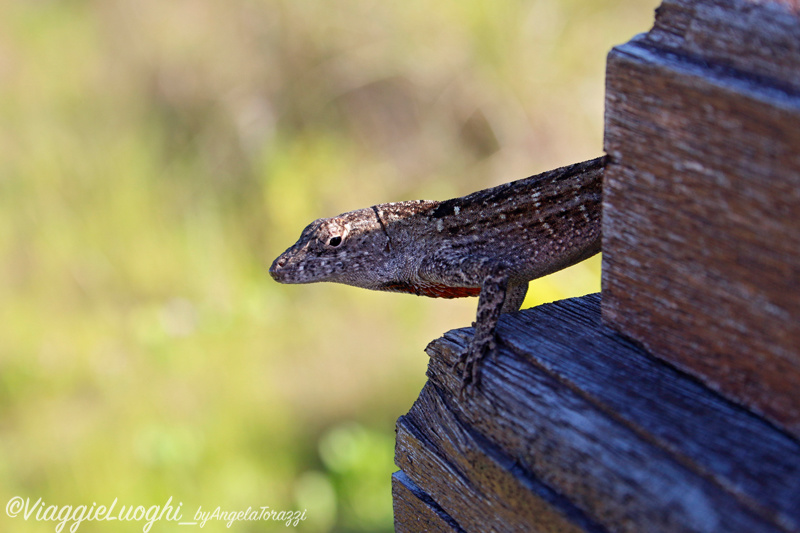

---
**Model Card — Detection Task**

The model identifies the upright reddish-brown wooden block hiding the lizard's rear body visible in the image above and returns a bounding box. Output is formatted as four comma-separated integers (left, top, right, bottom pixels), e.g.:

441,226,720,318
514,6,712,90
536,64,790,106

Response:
603,0,800,437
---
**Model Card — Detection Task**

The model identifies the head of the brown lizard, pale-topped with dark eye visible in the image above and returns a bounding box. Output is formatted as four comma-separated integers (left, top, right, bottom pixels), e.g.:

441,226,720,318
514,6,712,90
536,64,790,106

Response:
269,208,394,289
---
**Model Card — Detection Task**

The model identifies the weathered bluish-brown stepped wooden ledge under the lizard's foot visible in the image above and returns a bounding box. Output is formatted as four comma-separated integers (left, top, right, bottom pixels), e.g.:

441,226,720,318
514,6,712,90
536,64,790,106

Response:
395,295,800,532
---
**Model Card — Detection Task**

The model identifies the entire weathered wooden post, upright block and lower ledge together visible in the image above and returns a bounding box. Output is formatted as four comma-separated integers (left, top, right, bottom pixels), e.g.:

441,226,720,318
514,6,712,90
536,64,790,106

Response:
392,0,800,533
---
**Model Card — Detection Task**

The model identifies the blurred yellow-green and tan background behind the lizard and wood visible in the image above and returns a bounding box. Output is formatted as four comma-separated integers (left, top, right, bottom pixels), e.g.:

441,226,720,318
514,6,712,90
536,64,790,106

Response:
0,0,656,532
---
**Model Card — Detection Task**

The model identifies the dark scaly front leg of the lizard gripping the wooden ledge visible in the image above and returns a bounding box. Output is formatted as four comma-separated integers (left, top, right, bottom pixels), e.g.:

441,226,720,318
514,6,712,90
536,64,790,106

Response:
459,267,528,395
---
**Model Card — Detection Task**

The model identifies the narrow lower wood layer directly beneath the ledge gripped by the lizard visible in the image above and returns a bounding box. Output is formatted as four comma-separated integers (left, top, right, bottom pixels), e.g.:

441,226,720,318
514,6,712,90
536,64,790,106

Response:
395,383,602,533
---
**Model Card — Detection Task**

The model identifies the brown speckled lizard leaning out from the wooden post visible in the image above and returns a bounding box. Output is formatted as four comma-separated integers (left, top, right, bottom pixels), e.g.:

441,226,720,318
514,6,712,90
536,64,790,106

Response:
269,157,605,390
